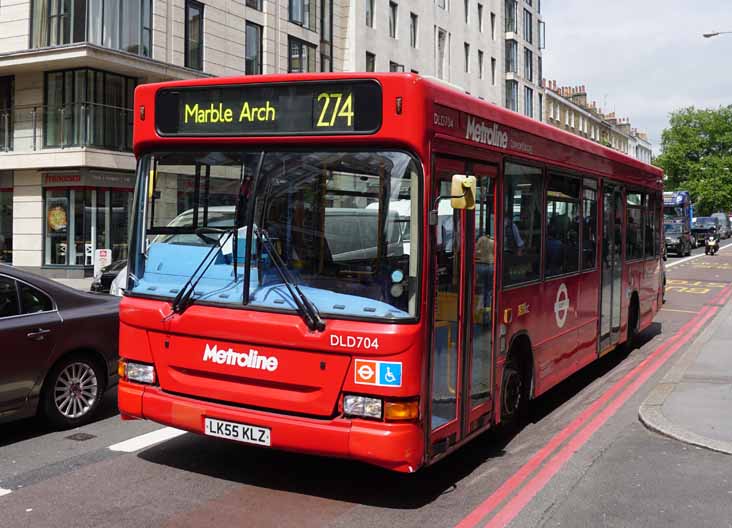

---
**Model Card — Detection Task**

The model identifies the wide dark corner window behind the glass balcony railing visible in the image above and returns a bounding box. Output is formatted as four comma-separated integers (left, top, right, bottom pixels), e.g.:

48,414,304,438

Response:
43,68,137,151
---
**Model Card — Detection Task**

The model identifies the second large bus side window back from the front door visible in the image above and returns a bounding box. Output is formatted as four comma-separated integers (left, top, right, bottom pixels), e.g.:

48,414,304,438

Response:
544,174,580,277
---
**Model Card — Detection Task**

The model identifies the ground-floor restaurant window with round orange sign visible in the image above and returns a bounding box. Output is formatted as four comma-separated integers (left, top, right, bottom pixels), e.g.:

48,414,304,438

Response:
44,186,134,267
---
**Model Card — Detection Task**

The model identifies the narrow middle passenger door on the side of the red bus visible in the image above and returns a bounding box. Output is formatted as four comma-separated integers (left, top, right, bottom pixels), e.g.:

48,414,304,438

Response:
599,183,625,355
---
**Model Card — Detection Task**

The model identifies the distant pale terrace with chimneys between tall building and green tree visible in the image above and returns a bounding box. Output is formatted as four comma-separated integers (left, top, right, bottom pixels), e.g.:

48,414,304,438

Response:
544,81,653,163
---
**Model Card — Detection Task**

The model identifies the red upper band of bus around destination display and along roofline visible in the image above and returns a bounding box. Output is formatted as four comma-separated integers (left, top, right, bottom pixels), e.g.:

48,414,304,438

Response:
134,73,663,189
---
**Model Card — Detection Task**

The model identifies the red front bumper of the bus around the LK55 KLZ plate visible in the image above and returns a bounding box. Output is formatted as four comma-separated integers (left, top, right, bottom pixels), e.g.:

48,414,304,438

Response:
118,381,424,473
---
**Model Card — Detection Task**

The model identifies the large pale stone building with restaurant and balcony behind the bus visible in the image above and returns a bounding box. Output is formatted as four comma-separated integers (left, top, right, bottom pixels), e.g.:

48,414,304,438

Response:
0,0,544,277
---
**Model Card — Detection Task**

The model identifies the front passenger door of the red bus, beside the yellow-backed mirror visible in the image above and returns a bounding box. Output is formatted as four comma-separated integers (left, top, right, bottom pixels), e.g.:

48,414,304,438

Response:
427,158,495,457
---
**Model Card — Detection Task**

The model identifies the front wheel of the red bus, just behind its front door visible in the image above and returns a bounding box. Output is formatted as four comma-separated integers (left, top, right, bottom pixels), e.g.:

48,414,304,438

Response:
501,344,531,430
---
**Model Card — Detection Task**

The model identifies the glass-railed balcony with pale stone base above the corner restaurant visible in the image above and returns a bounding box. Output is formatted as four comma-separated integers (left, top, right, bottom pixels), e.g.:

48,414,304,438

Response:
0,103,135,171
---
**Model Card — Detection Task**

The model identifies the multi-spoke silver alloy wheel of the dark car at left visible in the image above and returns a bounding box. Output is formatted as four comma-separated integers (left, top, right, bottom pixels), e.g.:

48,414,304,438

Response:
53,362,99,418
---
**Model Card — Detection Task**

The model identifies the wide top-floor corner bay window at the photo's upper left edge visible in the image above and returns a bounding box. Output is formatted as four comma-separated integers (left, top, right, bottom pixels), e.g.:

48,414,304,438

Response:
31,0,152,57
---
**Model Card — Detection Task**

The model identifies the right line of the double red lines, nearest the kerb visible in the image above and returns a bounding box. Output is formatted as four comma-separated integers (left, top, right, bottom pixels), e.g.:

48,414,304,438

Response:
485,307,719,528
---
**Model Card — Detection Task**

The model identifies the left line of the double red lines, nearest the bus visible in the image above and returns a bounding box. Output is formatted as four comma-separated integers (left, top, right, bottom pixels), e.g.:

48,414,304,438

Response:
456,285,732,528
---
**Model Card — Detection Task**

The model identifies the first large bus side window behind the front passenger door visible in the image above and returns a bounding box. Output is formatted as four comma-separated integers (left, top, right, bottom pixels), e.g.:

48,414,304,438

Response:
503,163,542,286
